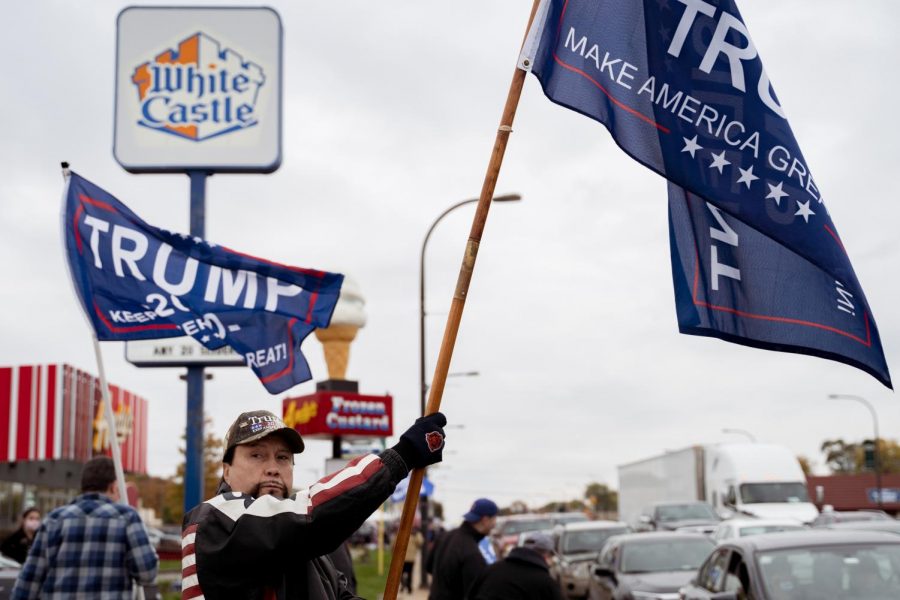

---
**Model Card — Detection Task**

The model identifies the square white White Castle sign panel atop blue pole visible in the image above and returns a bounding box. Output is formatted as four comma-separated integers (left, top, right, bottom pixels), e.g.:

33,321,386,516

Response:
114,7,281,172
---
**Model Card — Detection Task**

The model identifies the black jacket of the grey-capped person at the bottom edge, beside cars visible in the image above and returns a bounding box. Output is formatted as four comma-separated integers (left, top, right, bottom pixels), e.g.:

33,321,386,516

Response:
468,548,562,600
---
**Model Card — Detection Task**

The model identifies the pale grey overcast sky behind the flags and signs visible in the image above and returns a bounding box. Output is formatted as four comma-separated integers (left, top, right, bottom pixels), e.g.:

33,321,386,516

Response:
0,0,900,519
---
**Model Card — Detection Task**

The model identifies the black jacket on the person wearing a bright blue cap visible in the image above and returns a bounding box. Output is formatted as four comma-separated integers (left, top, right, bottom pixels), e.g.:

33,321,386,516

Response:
426,522,487,600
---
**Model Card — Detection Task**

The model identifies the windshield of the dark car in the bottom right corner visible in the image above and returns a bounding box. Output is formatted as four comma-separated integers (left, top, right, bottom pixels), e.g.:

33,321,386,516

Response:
757,544,900,600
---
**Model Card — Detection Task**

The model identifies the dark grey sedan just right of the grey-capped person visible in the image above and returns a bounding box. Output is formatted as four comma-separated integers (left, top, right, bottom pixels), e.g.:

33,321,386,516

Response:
588,531,716,600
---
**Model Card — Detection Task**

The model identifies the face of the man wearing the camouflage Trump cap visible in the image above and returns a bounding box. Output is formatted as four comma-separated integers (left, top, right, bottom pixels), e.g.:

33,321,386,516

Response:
223,435,294,498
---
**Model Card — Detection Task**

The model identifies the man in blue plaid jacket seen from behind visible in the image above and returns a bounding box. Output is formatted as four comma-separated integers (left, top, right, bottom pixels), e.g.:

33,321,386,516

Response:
12,456,159,600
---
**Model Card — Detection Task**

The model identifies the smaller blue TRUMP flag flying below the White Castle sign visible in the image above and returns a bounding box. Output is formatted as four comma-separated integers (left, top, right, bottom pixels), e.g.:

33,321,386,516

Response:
62,173,344,394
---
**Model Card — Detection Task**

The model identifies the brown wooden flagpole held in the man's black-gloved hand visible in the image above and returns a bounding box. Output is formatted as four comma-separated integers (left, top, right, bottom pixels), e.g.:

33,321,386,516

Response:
384,0,540,600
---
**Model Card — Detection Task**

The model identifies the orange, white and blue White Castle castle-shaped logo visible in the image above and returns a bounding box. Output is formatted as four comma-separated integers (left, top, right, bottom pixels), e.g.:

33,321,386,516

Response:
131,32,266,142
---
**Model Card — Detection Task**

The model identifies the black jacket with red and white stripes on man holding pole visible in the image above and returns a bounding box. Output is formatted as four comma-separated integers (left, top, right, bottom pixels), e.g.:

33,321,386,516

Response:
182,450,408,600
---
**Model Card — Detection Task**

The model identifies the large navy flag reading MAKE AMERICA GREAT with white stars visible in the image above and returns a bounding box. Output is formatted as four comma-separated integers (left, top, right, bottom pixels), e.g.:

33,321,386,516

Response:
520,0,891,387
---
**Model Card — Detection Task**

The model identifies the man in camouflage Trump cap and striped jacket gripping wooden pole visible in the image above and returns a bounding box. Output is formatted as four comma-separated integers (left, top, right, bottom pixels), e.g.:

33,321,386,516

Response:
181,410,447,600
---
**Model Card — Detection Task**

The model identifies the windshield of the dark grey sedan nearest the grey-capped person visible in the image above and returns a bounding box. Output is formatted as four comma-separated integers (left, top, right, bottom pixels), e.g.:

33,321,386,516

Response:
621,538,715,573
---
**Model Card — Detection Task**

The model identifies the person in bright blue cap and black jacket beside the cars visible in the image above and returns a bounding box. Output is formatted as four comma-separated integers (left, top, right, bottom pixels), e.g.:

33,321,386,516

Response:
426,498,499,600
